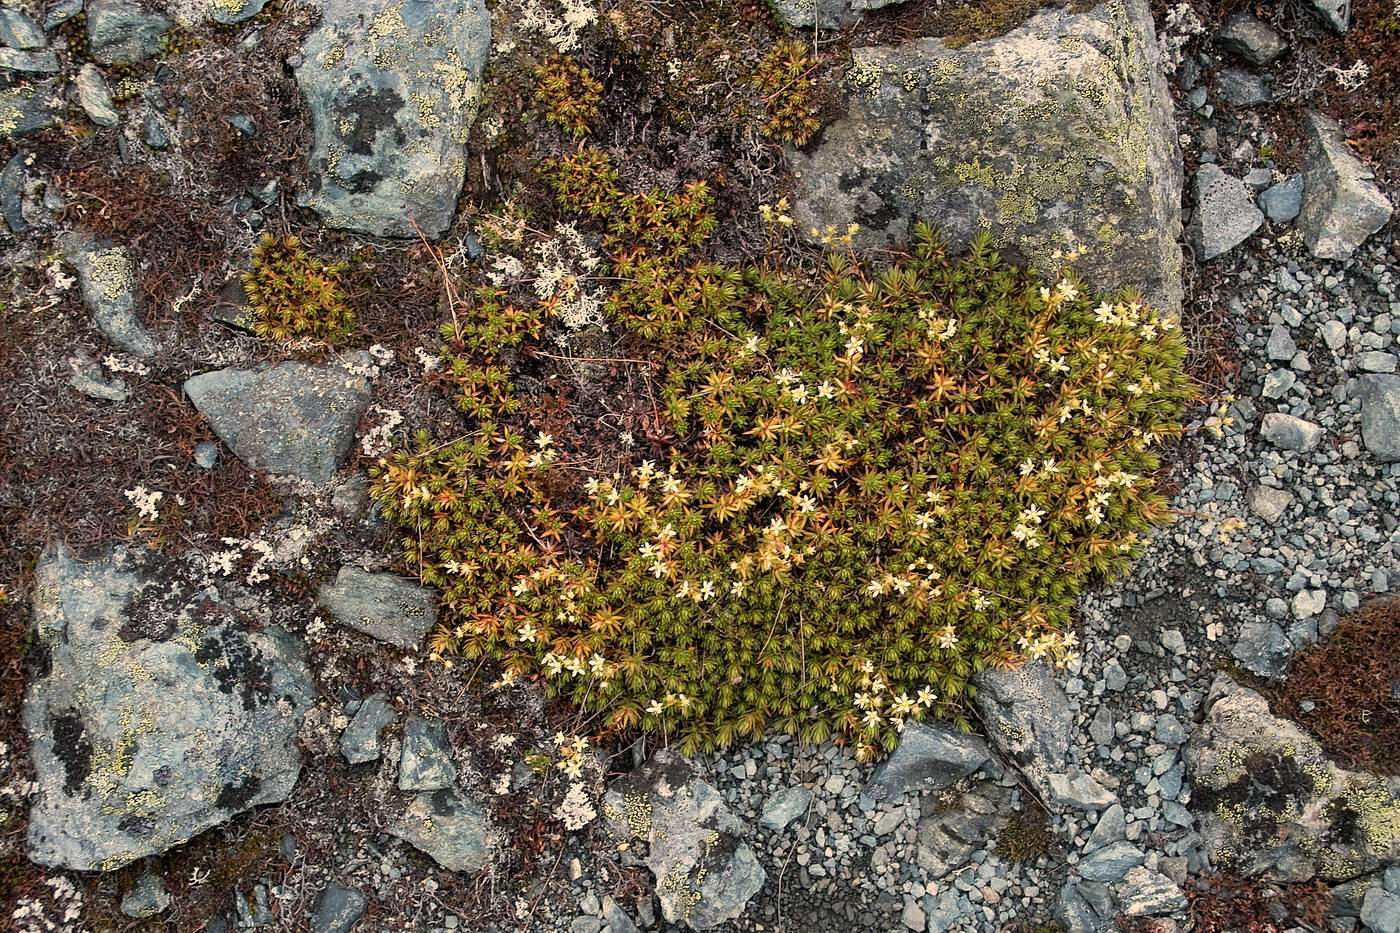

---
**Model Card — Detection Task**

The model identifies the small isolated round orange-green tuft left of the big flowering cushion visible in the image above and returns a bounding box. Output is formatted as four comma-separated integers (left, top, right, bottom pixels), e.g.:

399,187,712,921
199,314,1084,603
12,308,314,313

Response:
244,234,356,343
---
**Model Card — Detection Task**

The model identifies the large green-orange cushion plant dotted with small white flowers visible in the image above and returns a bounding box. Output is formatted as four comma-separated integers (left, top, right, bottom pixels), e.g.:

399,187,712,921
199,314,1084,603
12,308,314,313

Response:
374,151,1191,758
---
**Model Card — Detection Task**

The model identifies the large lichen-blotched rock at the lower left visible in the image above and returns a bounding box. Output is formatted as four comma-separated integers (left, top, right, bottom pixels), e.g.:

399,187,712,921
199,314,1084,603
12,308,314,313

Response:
22,545,314,871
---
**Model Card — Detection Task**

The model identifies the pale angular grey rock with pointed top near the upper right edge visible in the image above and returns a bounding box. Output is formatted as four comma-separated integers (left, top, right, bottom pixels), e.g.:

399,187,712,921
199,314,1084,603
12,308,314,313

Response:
1298,111,1394,259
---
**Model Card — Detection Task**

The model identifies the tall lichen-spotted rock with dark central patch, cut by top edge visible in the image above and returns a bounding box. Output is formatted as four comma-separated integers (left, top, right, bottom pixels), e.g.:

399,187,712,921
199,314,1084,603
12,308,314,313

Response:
297,0,491,237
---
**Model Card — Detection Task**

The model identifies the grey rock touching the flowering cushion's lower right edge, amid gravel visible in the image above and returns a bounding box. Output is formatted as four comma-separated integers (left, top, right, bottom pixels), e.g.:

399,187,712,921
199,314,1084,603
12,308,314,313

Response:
972,661,1074,794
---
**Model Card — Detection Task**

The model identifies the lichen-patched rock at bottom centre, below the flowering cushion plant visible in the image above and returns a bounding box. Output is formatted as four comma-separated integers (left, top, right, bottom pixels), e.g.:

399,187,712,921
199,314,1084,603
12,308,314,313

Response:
603,751,767,930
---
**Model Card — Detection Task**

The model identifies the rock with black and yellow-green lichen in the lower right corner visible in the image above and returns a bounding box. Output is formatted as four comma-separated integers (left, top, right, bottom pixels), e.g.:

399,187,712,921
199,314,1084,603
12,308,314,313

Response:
1184,674,1400,881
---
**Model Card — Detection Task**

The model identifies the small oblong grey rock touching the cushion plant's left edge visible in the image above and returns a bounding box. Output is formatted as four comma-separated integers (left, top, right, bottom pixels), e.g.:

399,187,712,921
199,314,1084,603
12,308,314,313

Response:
318,565,437,650
